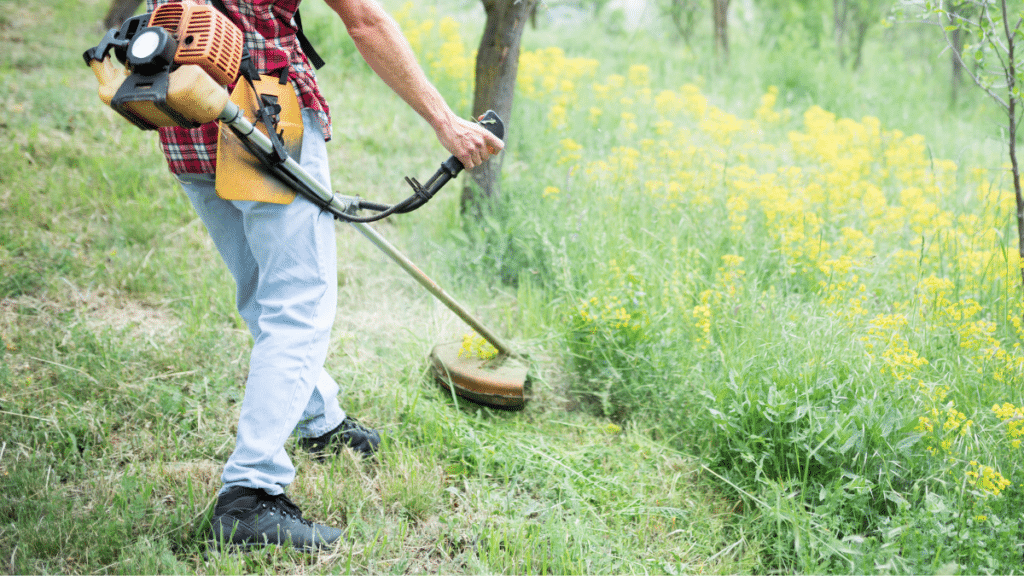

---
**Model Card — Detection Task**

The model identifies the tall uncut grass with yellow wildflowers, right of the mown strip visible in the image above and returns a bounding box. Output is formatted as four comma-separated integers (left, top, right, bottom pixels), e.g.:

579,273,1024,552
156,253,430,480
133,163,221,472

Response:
391,0,1024,573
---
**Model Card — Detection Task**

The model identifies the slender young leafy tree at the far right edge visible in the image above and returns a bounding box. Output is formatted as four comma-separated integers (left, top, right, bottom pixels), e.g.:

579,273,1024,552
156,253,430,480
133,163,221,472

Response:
927,0,1024,286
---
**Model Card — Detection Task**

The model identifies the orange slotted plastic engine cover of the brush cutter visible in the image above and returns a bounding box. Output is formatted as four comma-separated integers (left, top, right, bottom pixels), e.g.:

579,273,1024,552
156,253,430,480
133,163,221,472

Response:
150,0,245,85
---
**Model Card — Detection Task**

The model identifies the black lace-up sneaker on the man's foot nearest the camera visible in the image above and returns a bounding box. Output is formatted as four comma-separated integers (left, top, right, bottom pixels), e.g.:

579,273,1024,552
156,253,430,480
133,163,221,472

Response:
210,486,342,551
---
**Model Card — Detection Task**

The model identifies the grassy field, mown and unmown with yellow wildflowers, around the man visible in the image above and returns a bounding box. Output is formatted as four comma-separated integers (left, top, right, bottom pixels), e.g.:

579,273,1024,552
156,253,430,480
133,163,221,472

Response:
0,0,1024,574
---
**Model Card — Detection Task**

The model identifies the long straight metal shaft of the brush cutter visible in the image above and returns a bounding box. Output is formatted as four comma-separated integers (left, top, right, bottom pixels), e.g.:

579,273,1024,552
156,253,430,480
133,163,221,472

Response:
220,101,514,356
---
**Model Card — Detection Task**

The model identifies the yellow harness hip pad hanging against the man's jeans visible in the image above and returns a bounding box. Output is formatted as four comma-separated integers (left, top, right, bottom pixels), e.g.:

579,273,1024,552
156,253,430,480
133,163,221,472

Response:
216,76,302,204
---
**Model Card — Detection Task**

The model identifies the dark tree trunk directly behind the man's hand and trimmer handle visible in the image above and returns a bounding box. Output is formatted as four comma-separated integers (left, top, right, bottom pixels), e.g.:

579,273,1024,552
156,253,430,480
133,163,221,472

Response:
462,0,537,212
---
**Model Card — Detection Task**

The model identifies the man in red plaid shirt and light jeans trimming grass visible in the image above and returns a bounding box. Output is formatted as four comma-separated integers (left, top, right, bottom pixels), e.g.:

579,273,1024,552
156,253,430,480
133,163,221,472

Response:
147,0,504,549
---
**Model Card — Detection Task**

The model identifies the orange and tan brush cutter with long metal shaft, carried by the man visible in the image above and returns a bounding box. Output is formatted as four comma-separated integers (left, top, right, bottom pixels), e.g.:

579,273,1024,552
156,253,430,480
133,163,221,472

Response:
83,0,529,410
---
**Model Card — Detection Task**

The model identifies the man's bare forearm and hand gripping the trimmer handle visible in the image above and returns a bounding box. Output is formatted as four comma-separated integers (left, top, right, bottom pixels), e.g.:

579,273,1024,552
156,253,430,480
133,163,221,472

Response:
315,0,505,168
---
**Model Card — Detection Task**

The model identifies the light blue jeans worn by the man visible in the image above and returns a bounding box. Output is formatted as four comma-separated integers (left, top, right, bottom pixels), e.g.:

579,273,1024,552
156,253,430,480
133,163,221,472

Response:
178,110,345,494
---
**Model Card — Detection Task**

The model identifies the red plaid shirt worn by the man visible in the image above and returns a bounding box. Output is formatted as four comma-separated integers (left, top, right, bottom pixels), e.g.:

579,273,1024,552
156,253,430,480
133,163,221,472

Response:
146,0,331,174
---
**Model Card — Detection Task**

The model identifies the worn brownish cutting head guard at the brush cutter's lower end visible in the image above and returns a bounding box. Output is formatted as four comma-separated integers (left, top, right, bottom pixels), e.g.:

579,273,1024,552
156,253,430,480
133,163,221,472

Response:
430,341,529,410
